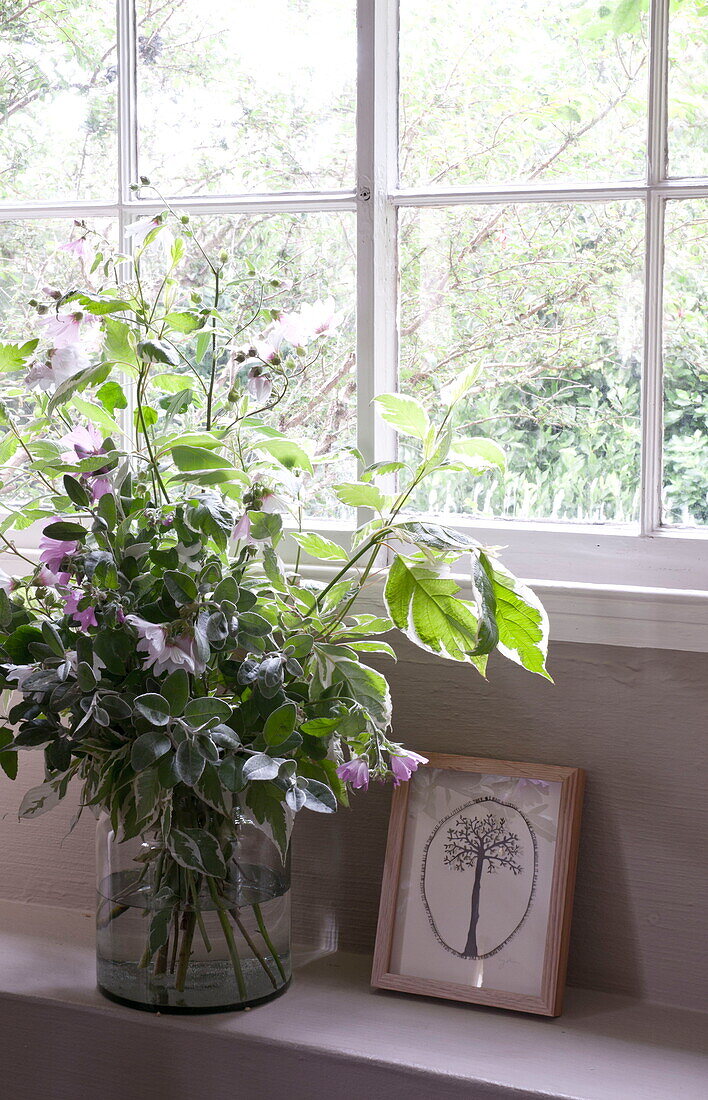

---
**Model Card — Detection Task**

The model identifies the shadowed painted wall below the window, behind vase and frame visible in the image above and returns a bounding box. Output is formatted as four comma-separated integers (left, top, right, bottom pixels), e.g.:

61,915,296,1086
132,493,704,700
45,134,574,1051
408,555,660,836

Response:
0,644,708,1008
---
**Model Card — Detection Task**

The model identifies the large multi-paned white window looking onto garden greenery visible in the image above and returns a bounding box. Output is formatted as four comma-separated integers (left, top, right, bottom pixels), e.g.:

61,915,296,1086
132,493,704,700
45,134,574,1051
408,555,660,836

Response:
0,0,708,589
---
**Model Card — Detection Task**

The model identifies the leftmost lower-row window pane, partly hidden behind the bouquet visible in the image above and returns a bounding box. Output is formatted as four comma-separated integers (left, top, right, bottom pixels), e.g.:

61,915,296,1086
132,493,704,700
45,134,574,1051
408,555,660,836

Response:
0,219,115,505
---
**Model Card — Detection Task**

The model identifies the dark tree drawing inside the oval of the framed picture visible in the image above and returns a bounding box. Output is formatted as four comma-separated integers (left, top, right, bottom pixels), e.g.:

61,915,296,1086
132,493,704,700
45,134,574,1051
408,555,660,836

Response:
444,812,523,958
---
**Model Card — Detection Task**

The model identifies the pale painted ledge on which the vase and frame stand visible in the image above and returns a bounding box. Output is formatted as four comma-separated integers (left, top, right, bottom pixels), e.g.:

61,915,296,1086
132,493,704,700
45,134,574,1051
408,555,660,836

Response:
0,902,706,1100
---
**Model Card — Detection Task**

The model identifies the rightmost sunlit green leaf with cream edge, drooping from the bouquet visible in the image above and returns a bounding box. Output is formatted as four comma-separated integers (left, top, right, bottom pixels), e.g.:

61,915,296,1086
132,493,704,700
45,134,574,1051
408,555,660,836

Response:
485,556,551,680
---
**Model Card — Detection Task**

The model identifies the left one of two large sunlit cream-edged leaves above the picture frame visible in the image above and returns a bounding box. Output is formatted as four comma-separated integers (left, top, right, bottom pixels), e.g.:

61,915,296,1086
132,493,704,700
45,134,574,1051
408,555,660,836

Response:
384,557,478,667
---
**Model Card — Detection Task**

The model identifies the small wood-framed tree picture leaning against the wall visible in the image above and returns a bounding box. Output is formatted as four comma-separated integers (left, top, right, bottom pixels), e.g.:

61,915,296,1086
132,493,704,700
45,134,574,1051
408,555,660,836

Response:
372,752,584,1016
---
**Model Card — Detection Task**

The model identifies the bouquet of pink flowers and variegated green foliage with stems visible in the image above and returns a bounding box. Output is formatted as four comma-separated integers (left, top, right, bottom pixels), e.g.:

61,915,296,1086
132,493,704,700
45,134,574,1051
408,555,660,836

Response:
0,200,547,1000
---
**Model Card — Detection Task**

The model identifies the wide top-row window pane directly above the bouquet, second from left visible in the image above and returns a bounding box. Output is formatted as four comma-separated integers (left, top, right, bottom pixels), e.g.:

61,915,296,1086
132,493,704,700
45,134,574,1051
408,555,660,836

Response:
137,0,356,194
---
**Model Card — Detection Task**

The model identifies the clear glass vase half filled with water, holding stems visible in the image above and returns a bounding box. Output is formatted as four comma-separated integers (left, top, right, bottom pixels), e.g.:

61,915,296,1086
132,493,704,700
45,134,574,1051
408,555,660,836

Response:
97,814,291,1012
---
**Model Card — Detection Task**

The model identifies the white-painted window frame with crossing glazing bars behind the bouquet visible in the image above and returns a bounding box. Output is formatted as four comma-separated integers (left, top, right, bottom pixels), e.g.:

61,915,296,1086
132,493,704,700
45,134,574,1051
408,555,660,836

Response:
0,0,708,649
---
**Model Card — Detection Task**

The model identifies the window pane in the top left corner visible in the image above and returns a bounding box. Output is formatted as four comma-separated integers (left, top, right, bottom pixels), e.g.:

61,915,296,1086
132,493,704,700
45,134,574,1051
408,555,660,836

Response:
0,0,118,201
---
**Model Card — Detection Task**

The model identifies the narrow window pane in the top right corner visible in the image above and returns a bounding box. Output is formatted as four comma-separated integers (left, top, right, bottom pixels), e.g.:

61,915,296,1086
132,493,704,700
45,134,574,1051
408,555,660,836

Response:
668,0,708,176
